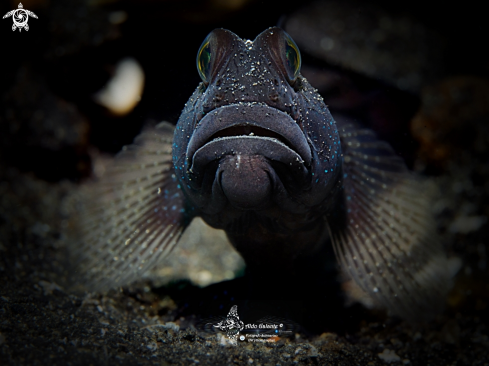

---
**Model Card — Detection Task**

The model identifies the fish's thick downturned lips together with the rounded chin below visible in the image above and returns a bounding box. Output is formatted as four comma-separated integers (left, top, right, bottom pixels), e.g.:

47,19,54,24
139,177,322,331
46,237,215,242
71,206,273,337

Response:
187,103,312,209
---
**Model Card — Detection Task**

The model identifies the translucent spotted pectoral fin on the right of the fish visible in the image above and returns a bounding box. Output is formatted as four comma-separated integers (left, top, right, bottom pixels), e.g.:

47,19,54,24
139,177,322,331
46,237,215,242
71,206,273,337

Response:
328,119,460,319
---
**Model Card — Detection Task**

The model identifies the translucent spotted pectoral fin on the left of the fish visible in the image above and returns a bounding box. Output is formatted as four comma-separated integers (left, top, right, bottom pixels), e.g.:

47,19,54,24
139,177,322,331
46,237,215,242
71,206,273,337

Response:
66,122,188,291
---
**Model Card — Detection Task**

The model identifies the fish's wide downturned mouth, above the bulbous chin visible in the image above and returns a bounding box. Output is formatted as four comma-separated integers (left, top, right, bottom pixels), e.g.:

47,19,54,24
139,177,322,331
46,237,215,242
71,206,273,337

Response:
187,103,312,172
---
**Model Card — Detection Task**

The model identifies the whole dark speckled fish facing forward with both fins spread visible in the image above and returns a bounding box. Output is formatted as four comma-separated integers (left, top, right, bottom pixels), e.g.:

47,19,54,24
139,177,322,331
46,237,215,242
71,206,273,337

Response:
66,27,460,319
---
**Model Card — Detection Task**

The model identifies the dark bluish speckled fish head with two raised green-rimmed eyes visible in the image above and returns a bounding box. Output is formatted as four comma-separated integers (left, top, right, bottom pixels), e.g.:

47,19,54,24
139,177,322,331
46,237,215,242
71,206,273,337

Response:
172,28,341,228
